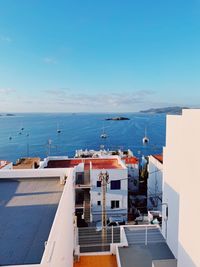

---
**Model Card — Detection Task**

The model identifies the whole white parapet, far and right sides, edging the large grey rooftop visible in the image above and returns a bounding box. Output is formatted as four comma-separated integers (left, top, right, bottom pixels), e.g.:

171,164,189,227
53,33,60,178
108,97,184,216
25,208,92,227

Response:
0,168,75,267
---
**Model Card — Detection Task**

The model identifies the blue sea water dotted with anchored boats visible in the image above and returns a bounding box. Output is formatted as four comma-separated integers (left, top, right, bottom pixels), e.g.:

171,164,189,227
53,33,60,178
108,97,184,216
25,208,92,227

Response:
0,113,166,161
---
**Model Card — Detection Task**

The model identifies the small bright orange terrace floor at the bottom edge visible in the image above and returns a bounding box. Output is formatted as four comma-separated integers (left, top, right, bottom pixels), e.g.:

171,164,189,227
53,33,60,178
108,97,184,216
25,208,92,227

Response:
74,255,117,267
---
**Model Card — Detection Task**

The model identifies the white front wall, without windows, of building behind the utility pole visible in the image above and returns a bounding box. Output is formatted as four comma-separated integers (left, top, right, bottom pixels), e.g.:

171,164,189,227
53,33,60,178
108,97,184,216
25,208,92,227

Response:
90,169,128,221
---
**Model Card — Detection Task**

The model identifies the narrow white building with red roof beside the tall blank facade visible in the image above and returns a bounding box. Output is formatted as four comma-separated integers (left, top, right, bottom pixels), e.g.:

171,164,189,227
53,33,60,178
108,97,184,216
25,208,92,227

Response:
147,155,163,211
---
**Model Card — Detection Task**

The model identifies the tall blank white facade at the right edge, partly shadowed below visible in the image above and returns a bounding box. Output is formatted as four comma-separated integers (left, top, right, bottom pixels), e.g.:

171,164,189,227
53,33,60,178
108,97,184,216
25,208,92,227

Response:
163,109,200,267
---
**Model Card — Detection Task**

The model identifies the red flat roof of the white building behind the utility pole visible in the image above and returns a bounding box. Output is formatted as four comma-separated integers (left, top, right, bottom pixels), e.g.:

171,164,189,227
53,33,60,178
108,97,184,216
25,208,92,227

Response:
47,158,123,170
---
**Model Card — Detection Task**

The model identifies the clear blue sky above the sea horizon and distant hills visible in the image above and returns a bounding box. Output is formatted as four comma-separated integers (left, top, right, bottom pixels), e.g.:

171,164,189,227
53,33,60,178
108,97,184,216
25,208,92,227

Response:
0,0,200,112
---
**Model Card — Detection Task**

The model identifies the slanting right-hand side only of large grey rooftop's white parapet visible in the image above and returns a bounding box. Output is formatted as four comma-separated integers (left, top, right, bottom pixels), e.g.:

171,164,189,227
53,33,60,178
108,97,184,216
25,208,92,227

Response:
41,169,75,267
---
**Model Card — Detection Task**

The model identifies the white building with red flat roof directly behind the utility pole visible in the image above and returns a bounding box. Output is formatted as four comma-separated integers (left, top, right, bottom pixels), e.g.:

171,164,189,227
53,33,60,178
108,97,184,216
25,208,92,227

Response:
43,156,128,223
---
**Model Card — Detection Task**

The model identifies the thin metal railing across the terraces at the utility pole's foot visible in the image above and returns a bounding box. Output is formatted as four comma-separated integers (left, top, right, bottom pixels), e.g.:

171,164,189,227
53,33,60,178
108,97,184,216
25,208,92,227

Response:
77,225,165,253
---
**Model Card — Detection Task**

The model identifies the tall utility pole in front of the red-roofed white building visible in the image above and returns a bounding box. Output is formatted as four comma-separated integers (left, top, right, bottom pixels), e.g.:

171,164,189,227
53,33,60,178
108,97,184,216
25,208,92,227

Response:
99,171,109,243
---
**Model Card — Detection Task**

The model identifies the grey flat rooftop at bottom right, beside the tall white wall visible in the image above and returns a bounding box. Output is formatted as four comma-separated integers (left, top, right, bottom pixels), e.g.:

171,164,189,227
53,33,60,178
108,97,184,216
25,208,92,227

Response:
119,225,174,267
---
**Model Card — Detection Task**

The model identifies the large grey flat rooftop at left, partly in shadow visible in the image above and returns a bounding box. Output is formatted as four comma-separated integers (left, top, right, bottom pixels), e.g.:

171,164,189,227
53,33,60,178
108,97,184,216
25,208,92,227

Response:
0,178,63,265
